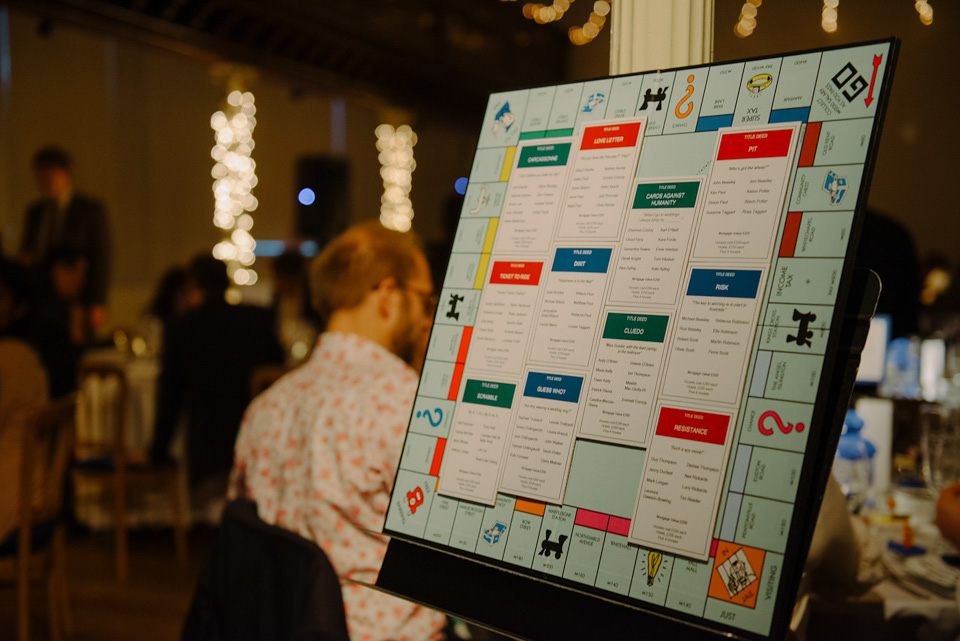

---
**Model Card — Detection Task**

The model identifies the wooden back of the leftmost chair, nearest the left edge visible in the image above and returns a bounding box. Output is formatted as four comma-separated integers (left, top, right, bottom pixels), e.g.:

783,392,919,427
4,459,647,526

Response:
19,394,77,536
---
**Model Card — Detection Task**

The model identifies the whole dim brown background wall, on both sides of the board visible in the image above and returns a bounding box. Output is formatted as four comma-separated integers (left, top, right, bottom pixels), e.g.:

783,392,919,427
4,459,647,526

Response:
0,0,960,323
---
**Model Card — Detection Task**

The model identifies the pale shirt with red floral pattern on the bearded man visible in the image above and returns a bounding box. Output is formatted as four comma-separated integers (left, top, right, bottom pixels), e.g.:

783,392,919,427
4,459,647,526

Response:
229,333,446,641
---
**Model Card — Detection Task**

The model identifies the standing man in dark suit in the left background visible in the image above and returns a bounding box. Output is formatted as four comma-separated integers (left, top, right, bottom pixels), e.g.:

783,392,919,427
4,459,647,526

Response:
19,147,110,339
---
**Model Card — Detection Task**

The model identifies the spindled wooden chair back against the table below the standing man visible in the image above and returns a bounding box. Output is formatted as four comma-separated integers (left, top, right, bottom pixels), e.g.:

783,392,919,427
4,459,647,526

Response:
76,362,130,465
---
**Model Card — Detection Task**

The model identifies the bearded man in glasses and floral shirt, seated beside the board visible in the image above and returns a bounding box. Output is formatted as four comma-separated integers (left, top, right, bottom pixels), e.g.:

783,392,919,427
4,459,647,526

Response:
230,222,445,641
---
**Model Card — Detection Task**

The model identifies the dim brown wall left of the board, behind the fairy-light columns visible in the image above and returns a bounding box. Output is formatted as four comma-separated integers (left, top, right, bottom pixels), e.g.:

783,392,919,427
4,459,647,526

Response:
0,10,476,324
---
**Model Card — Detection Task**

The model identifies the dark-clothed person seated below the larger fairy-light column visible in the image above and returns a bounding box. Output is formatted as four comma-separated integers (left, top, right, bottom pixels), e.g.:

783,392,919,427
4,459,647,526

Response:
149,254,283,504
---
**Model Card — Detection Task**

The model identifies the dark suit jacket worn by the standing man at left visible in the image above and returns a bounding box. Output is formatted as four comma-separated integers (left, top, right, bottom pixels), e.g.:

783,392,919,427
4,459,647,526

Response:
20,193,110,306
